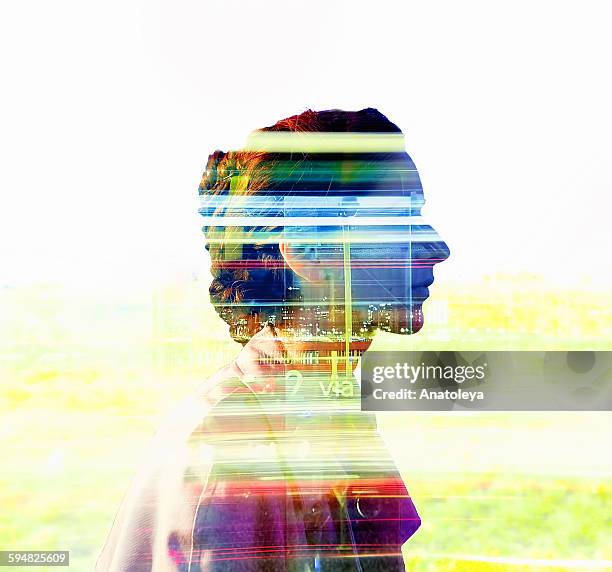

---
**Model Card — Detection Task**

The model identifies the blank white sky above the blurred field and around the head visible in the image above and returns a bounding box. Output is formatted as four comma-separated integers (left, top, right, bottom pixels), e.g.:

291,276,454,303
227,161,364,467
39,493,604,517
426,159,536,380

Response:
0,0,612,287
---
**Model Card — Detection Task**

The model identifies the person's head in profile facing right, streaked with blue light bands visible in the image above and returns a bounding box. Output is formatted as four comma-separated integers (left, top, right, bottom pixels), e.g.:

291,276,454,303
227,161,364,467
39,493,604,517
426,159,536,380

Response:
199,108,449,342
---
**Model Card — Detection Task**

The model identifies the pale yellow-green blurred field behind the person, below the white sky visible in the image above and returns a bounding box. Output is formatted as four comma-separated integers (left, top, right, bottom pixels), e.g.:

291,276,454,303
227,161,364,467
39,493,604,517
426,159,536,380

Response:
0,274,612,572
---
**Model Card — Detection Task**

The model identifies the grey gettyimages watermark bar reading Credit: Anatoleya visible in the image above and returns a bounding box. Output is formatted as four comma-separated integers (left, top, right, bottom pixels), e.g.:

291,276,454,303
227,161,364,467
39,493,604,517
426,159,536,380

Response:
361,351,612,411
